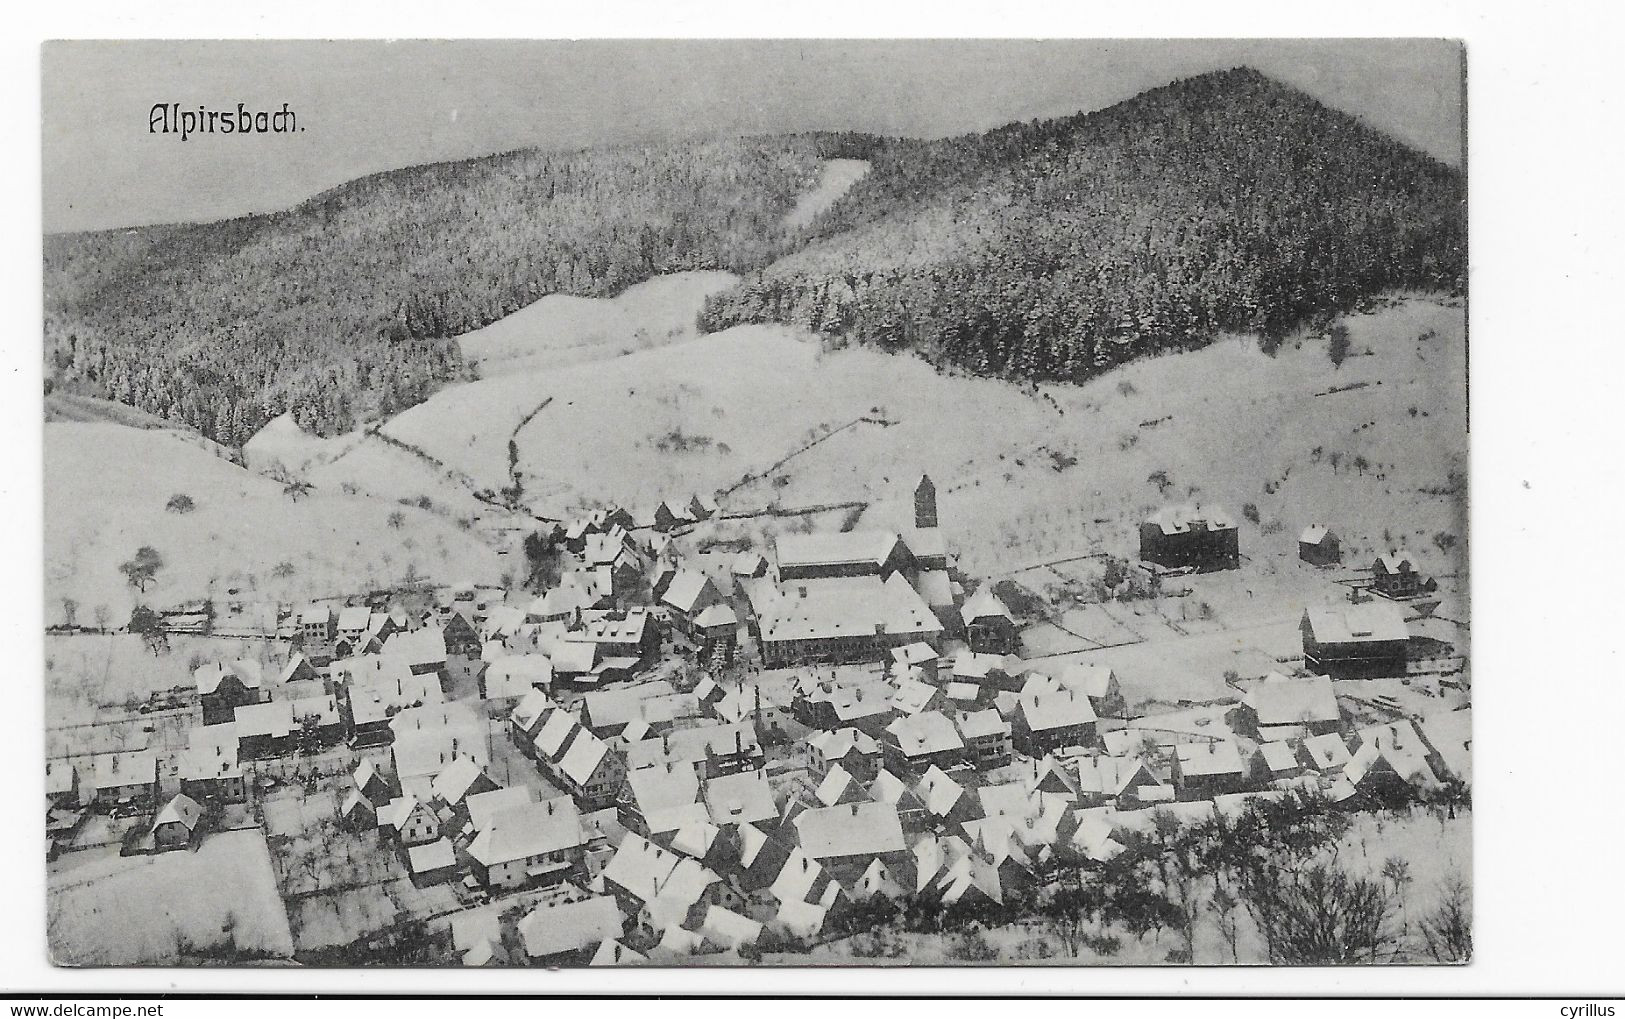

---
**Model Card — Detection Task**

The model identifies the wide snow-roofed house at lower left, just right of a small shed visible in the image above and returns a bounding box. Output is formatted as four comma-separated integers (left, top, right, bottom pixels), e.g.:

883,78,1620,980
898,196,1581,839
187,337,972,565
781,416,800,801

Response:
468,796,587,889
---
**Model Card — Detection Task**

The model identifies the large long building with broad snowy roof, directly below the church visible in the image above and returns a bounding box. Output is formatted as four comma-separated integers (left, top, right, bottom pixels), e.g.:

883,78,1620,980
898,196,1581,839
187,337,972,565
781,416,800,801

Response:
752,572,943,668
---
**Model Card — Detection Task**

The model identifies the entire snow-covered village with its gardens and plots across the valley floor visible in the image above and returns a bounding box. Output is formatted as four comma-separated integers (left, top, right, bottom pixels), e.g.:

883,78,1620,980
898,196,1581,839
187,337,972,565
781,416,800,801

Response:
47,458,1471,965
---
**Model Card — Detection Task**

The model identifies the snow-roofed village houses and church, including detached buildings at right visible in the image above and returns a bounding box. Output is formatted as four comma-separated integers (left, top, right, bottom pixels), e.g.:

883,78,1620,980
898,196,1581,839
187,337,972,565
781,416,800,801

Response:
47,478,1471,965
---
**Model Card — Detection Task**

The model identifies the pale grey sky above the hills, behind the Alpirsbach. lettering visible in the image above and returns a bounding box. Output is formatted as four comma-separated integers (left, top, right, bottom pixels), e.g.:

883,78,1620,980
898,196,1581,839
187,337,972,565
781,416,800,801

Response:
41,39,1464,232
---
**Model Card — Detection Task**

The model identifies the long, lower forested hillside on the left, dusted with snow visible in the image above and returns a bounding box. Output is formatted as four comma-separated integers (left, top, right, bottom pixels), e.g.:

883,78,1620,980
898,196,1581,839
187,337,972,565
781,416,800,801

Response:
46,137,821,445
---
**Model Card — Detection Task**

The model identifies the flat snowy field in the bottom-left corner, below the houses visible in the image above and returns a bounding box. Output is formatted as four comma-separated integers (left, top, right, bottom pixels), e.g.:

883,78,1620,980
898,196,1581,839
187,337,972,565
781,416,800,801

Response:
46,830,294,965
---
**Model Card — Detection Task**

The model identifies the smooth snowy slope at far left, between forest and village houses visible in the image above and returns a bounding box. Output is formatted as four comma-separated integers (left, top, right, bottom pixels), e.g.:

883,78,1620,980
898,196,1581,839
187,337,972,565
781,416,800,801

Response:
46,424,501,626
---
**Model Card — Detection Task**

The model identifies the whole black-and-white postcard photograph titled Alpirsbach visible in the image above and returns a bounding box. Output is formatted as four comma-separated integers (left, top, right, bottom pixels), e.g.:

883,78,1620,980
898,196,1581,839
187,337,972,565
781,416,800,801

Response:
34,37,1475,969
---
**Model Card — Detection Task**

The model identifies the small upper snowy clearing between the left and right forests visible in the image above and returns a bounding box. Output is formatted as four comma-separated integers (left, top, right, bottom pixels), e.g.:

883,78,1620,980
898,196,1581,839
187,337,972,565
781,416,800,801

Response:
457,270,739,379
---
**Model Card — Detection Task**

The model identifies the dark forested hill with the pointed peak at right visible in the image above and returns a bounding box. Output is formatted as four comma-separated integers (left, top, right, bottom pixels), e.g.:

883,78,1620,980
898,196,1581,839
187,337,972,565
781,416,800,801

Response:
702,68,1466,379
